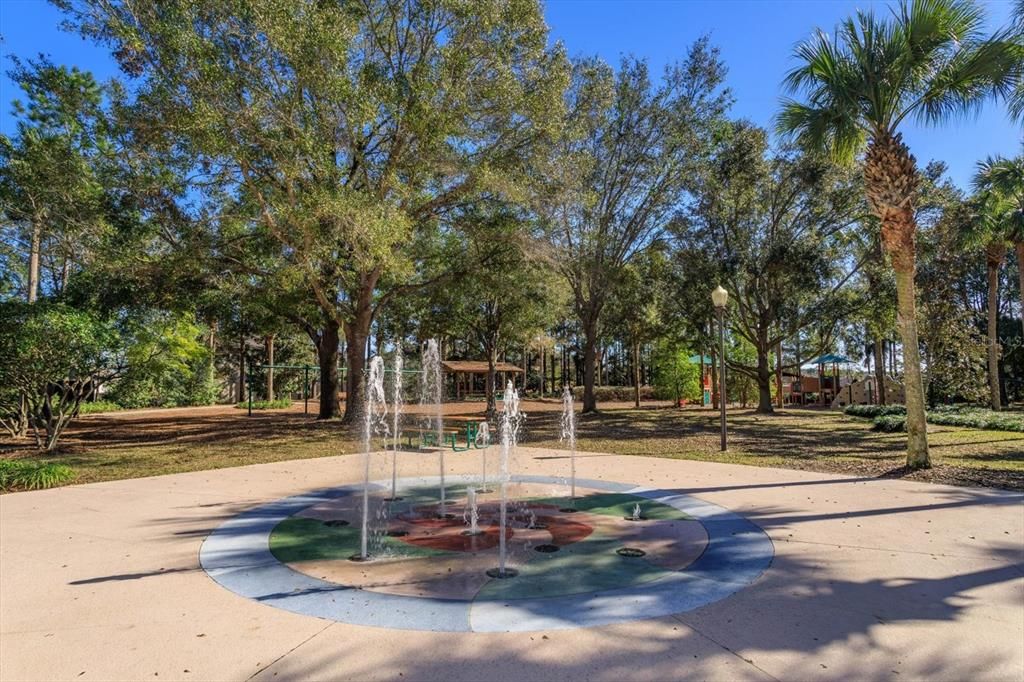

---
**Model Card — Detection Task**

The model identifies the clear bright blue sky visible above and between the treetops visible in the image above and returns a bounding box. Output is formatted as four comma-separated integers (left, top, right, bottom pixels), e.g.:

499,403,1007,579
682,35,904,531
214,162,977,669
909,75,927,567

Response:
0,0,1022,186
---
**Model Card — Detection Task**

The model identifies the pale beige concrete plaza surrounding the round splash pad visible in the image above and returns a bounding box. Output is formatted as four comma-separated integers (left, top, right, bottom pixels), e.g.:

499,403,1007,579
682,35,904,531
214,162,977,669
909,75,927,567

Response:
0,449,1024,682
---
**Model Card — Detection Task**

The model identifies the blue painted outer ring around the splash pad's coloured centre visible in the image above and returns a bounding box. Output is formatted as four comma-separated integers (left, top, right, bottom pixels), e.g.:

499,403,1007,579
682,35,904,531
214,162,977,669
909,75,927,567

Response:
200,476,775,632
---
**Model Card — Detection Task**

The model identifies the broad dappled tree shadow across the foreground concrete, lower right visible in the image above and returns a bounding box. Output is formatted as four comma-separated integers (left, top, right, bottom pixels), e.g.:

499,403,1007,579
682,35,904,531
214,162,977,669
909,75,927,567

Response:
241,550,1024,681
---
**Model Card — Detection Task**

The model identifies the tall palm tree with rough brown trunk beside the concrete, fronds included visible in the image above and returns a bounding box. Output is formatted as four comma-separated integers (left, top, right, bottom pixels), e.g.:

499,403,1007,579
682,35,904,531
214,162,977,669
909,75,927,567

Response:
778,0,1022,468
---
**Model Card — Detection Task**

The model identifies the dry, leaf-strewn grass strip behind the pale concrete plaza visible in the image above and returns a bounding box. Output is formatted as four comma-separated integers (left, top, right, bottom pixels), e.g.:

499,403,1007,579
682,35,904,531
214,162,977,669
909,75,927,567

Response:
0,399,1024,489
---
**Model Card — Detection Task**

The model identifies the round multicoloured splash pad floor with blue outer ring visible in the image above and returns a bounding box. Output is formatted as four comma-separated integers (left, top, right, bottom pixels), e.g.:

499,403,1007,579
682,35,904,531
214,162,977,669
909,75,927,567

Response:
200,476,774,632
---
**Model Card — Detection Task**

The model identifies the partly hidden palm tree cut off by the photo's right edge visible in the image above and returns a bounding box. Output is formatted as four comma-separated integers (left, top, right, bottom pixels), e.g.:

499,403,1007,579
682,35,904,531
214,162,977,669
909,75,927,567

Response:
974,155,1024,335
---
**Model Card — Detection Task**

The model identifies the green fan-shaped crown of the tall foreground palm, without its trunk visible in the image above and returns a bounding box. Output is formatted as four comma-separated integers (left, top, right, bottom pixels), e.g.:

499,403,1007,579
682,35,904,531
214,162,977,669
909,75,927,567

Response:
777,0,1024,142
